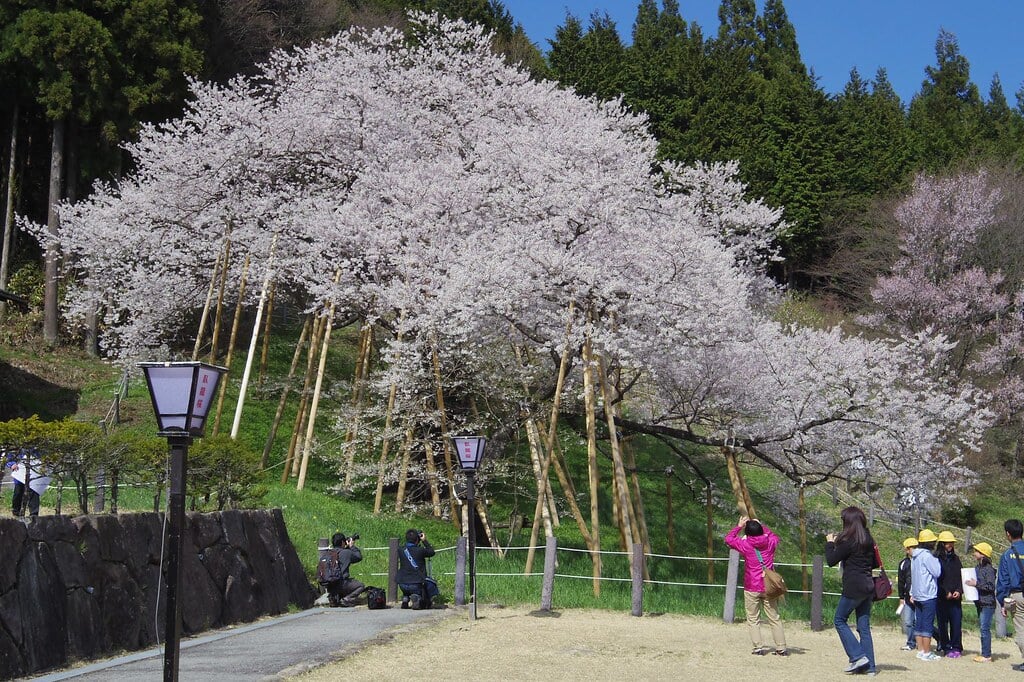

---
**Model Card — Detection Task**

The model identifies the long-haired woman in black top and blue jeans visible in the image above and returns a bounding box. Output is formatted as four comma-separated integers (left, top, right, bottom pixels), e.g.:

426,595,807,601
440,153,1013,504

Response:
825,507,878,675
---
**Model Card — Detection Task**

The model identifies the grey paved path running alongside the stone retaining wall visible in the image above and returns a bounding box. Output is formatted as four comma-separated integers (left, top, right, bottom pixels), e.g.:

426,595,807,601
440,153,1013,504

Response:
33,606,450,682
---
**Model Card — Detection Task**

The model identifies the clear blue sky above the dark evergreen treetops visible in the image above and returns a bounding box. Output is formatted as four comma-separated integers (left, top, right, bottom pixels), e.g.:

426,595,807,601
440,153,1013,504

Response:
502,0,1024,106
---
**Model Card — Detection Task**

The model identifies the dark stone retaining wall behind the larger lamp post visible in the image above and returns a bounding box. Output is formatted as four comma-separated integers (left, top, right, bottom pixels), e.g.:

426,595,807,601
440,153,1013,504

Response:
0,509,317,679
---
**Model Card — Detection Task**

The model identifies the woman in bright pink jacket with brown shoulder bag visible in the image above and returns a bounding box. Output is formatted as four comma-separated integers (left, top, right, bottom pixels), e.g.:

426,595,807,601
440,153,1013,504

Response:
725,516,790,656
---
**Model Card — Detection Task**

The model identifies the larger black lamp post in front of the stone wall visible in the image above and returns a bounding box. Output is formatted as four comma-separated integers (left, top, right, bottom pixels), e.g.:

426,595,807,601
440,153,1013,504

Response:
139,363,227,682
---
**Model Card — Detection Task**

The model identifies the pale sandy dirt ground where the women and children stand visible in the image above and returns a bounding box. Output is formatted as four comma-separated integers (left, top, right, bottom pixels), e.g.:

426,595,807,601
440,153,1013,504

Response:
293,604,1024,682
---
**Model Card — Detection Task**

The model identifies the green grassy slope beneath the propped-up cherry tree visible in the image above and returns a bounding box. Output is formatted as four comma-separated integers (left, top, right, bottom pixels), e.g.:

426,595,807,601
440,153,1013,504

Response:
0,323,1022,619
